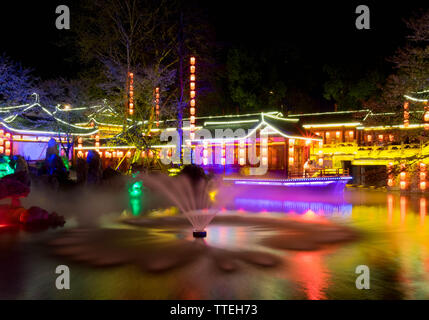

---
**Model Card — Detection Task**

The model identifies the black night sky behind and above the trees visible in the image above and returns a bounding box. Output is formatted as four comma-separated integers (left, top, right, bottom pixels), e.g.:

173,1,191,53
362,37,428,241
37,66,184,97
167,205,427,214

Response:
0,0,427,111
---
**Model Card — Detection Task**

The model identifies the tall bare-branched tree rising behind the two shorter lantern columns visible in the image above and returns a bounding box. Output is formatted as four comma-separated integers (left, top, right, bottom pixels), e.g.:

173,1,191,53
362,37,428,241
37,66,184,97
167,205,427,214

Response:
71,0,217,160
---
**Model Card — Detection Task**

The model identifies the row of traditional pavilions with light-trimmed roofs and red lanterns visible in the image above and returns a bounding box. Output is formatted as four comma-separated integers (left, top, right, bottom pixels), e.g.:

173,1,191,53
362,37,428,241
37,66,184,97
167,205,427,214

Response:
0,91,429,190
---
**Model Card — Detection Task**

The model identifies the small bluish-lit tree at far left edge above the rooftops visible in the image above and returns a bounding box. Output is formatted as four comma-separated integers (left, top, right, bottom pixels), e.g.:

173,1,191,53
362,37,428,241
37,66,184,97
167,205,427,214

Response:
0,53,37,105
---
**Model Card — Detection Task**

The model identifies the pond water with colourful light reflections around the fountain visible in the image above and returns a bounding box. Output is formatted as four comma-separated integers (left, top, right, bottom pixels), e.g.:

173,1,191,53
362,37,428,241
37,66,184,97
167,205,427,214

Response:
0,189,429,299
